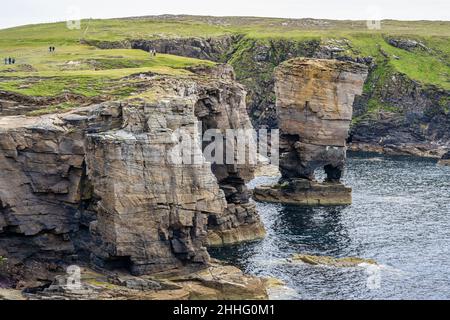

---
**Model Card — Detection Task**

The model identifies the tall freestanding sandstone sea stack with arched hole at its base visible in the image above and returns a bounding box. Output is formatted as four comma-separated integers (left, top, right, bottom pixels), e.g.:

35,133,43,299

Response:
254,58,368,205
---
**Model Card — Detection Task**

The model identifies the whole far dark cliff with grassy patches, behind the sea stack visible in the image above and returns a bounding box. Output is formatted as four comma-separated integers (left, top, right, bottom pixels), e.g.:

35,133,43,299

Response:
82,31,450,158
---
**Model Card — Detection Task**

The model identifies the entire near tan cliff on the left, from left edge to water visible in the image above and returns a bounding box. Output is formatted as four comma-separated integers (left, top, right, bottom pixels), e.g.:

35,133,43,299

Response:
0,68,263,274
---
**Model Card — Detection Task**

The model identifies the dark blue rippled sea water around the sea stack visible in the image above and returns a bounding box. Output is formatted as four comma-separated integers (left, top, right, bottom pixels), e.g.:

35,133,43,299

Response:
210,154,450,299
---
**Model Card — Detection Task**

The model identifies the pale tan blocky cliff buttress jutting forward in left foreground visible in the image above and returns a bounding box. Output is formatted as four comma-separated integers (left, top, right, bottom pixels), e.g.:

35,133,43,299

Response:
86,98,221,274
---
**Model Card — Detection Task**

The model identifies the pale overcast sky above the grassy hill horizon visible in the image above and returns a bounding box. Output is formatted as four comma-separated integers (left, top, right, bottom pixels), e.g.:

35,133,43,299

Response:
0,0,450,28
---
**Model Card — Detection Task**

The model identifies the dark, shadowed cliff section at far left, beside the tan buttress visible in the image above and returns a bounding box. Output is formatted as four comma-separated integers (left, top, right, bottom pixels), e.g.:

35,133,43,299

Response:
0,116,89,261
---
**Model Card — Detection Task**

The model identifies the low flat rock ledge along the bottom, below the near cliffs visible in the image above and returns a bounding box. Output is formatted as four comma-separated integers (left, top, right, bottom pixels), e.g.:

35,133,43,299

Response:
0,263,268,300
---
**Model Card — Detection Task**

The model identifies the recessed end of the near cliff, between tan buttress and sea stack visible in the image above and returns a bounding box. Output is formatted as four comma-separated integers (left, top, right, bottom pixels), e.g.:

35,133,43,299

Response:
195,79,265,246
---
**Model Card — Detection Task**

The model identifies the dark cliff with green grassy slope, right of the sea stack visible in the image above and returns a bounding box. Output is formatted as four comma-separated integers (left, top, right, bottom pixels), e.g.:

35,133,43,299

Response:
349,70,450,159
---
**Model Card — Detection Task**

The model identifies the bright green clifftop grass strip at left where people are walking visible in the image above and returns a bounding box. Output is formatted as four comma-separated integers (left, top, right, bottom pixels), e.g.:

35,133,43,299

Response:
0,44,212,76
